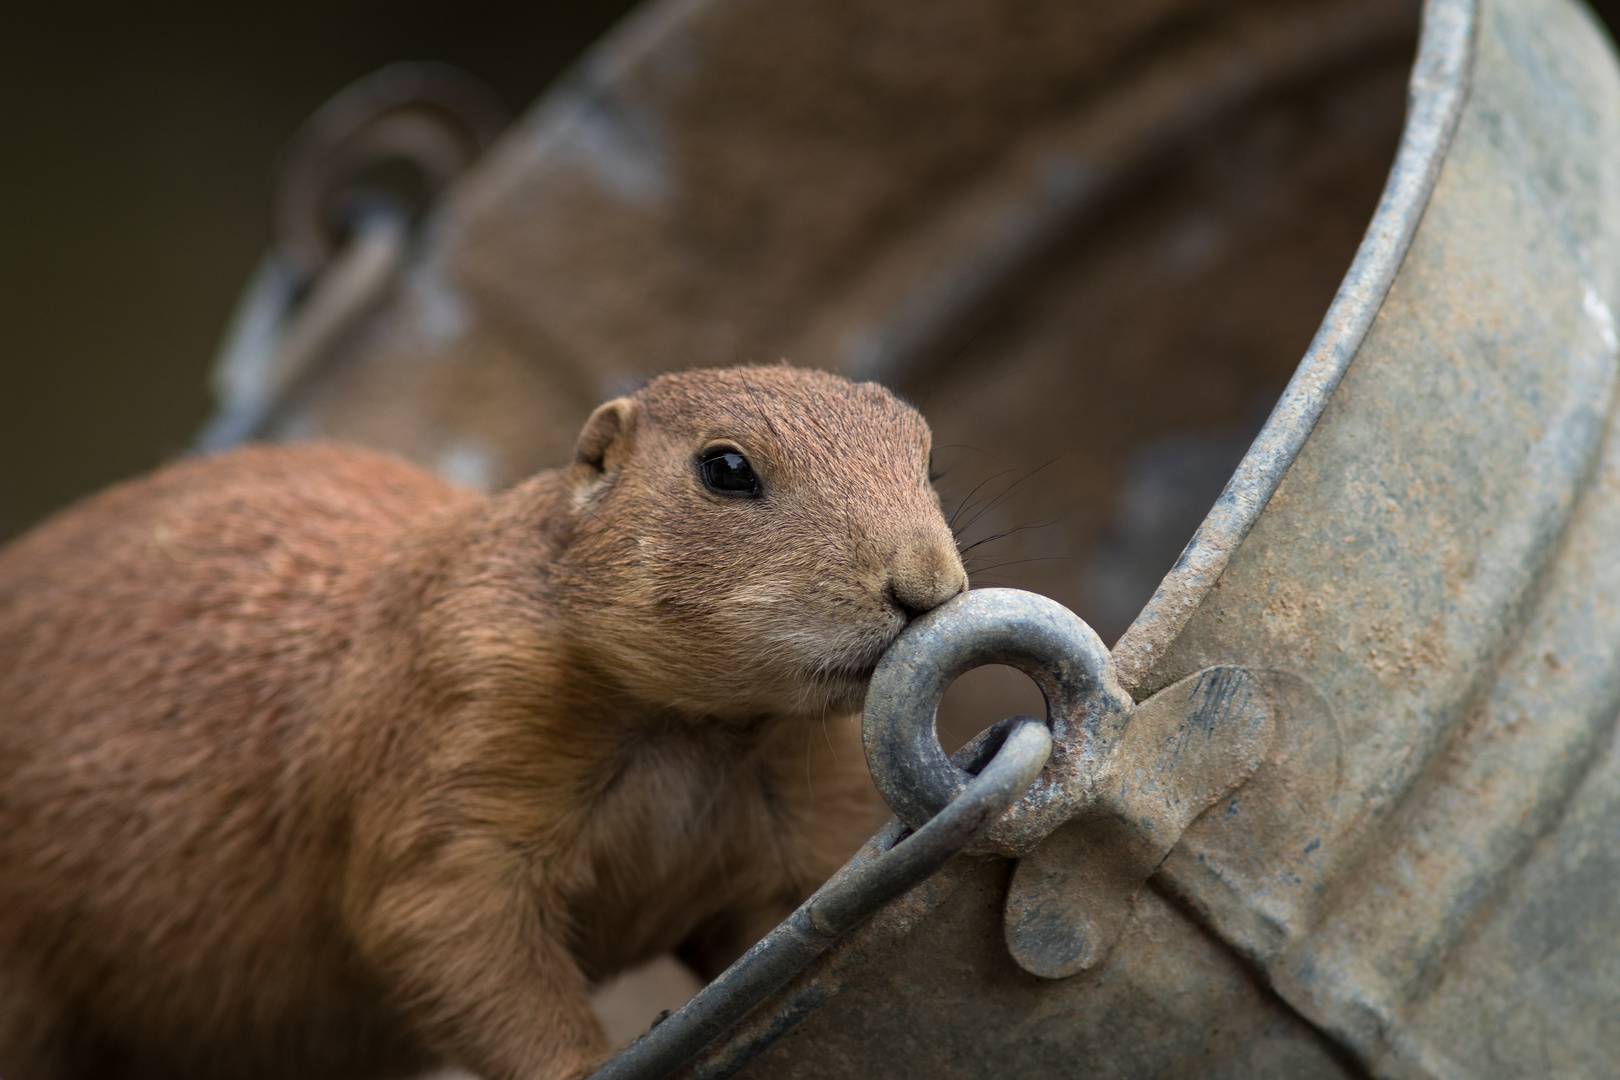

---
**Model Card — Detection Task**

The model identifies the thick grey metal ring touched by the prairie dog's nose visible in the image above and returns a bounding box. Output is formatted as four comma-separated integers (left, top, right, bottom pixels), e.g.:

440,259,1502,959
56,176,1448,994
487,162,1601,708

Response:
862,589,1131,855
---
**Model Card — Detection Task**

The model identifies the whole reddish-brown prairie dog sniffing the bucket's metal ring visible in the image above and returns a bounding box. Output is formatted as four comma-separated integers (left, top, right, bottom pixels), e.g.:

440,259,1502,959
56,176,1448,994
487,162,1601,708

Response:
0,368,967,1080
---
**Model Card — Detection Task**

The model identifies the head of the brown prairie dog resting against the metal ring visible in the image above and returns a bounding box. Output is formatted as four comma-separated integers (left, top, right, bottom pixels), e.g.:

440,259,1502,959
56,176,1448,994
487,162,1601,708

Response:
556,366,967,717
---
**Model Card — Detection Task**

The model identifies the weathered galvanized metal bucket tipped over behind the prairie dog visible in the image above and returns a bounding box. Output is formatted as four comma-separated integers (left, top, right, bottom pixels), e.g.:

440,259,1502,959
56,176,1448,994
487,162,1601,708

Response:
218,0,1620,1077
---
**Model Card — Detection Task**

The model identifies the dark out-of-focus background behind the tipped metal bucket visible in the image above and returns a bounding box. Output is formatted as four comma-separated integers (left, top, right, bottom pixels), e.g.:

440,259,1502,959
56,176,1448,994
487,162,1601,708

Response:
0,0,1620,539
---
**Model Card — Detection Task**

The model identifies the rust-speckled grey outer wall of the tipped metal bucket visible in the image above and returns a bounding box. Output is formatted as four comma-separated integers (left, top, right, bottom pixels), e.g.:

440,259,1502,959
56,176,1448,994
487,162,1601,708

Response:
716,0,1620,1077
